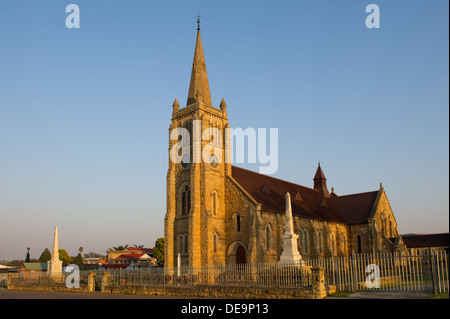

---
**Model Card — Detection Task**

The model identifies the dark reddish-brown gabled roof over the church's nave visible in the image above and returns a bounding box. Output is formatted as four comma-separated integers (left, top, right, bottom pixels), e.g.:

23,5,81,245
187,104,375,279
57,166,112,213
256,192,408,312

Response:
232,166,378,224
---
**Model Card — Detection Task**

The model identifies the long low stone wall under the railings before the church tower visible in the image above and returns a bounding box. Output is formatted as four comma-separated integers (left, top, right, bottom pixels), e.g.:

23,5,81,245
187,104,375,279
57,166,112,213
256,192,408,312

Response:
103,285,314,299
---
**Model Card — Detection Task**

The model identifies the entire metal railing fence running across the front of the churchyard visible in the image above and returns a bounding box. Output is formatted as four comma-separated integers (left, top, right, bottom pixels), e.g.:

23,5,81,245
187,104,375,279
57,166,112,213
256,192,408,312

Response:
7,251,449,293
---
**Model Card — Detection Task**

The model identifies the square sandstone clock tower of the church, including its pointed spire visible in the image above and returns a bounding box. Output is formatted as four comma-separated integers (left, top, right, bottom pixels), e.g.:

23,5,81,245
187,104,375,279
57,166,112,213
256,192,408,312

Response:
164,21,231,269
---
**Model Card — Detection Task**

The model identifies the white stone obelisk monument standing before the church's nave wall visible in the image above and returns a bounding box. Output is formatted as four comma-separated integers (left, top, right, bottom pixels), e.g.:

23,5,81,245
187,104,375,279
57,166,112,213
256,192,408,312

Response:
278,192,303,265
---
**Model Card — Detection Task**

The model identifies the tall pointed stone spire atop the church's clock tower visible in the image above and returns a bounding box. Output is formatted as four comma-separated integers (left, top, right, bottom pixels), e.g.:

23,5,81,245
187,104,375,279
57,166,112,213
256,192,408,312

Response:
186,19,212,106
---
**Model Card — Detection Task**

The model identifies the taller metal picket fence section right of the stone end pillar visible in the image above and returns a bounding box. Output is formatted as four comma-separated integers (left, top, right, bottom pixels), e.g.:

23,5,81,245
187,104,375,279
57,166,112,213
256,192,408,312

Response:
307,250,449,293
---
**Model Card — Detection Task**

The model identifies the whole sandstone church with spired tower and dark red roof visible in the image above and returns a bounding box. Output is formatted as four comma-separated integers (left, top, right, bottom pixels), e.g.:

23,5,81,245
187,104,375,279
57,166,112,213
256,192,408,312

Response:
164,27,402,268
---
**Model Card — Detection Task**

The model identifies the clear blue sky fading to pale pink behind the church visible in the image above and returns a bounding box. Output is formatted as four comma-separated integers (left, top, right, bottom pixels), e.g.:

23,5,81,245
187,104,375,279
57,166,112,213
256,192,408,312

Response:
0,0,449,260
